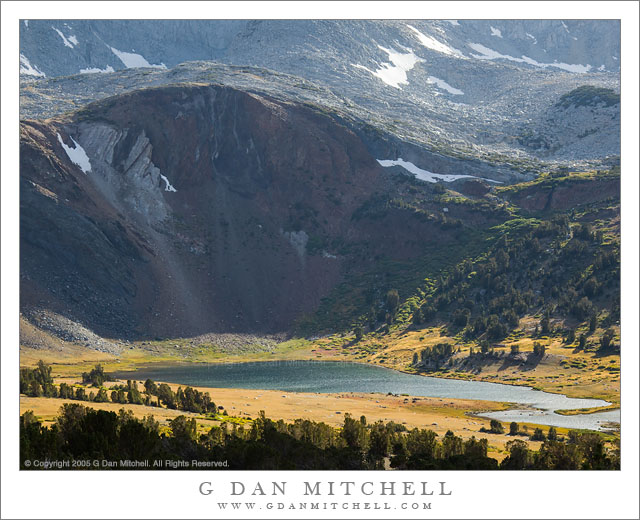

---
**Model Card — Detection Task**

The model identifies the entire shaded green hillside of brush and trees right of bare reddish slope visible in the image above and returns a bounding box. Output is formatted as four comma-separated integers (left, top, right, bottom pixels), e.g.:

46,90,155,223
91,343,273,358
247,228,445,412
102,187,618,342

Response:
297,168,620,357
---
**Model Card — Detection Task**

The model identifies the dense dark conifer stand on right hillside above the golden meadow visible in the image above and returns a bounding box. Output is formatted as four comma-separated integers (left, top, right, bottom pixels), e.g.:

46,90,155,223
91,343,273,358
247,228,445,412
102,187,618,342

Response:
404,205,620,348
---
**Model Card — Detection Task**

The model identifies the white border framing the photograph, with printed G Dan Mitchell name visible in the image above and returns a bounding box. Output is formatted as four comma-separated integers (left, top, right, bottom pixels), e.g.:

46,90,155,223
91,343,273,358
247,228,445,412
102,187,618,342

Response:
1,2,639,518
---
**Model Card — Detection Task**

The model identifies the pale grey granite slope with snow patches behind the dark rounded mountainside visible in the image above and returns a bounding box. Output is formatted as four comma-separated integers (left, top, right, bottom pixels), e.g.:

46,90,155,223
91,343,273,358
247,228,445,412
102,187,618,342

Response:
21,20,620,167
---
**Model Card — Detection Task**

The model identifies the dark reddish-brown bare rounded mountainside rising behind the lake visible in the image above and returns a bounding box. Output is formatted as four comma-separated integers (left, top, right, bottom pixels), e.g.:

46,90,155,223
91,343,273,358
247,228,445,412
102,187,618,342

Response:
21,85,500,337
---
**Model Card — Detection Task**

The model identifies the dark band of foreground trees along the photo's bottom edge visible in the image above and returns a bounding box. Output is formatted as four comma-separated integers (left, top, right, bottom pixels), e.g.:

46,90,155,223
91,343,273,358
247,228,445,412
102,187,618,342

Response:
20,403,620,470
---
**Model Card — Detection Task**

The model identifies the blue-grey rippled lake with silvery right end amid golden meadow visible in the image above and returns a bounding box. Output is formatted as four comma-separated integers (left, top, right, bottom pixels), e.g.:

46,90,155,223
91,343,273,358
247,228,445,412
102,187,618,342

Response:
117,361,620,430
